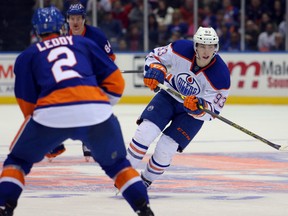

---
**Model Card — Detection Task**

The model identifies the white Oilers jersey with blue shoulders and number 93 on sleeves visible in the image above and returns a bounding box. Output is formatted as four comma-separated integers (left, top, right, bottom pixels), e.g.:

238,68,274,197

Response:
144,40,230,120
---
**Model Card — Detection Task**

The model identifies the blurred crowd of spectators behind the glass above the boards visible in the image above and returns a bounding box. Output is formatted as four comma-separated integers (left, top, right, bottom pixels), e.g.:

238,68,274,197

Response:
0,0,287,52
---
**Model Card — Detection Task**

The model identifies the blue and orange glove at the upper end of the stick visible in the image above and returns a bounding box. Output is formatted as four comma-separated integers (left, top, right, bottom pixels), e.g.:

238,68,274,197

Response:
144,64,167,91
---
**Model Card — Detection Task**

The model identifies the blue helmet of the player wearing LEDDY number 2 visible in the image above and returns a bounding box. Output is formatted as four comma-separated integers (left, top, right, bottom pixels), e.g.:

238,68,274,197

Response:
32,6,65,35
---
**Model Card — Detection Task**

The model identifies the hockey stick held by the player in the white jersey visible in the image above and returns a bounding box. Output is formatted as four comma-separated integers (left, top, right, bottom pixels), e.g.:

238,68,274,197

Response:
158,83,288,151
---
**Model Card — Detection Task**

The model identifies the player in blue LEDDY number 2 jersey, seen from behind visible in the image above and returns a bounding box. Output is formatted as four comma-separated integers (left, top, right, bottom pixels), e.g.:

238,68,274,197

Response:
0,7,154,216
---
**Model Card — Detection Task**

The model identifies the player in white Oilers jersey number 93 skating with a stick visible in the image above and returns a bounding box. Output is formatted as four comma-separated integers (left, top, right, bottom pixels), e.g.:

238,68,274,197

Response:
128,27,230,187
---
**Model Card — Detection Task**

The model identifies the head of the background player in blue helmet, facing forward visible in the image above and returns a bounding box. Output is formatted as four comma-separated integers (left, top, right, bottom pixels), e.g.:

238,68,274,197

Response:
66,3,86,35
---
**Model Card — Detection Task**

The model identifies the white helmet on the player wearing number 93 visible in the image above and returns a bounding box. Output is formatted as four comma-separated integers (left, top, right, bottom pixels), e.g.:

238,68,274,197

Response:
193,26,219,54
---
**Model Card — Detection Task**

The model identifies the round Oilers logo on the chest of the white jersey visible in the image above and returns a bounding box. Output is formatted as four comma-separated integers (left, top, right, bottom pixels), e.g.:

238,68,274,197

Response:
175,73,200,96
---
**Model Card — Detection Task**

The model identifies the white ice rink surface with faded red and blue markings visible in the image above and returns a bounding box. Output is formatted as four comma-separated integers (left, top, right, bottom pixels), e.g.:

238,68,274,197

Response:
0,104,288,216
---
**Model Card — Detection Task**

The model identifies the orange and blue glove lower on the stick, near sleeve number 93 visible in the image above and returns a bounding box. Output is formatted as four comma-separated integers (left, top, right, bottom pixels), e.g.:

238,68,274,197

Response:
183,95,207,116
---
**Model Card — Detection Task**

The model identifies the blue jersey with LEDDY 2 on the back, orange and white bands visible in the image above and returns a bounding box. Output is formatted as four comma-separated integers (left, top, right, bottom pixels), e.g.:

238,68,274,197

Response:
14,36,124,128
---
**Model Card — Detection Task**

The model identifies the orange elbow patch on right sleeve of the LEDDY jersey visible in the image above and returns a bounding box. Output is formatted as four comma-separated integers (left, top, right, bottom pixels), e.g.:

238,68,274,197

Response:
101,69,125,95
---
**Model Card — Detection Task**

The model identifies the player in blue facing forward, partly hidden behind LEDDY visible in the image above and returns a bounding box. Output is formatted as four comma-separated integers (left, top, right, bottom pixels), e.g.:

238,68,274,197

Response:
46,3,116,161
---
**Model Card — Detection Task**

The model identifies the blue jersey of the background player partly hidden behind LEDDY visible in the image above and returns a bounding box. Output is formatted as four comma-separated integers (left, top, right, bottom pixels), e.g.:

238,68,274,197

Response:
69,25,116,61
